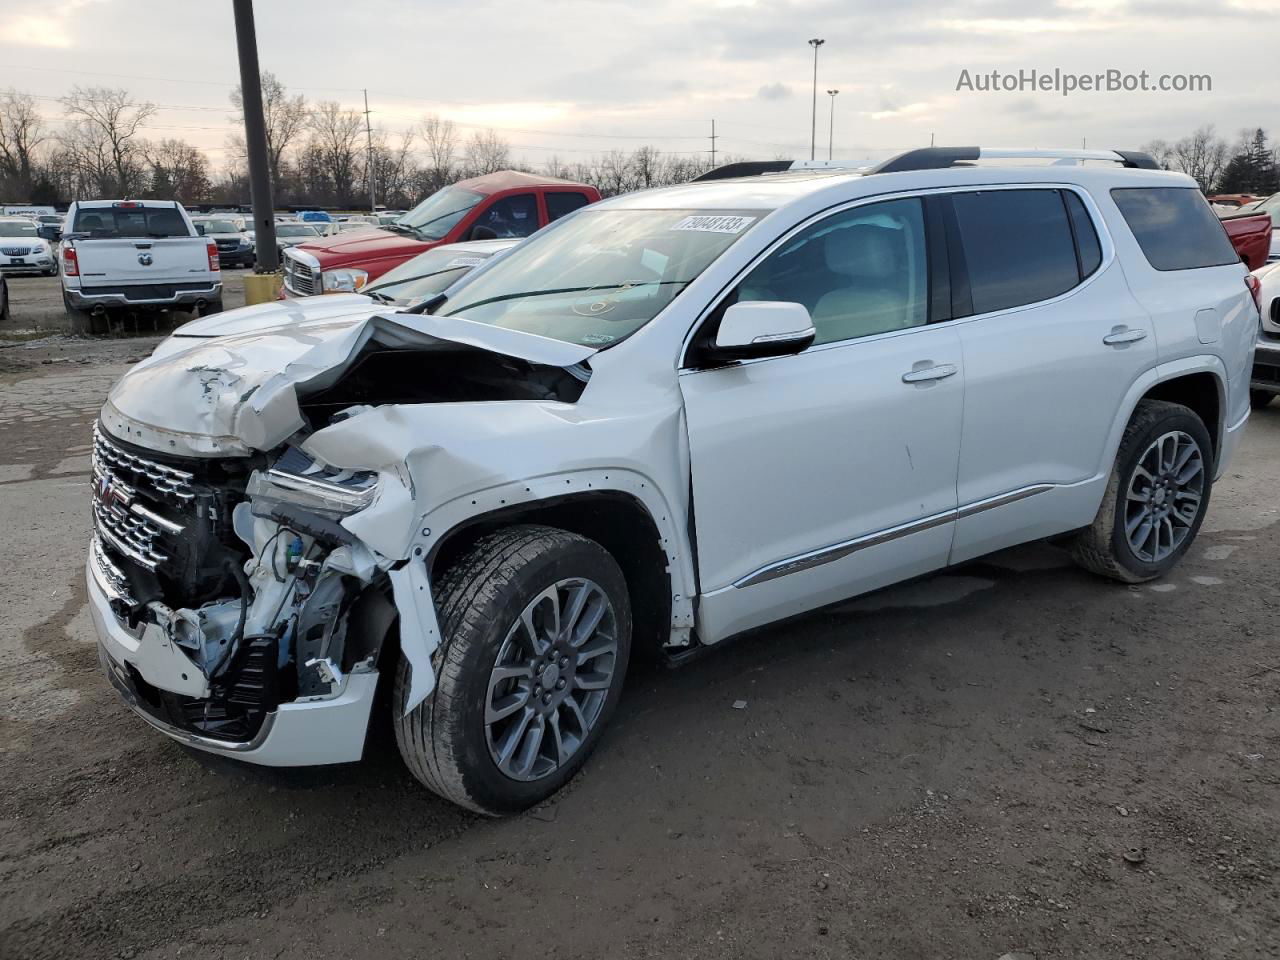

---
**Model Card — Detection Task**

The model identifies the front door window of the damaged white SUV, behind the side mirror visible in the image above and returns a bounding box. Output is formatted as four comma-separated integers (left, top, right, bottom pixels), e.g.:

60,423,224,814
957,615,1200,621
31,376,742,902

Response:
737,198,929,343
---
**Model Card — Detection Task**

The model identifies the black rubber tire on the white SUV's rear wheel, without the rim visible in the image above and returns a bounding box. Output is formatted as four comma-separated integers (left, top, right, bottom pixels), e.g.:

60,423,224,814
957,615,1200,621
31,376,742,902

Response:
1071,401,1213,584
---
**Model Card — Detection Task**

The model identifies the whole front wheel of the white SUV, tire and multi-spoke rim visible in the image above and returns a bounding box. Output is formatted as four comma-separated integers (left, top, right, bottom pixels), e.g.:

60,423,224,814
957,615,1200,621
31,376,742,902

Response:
393,526,631,815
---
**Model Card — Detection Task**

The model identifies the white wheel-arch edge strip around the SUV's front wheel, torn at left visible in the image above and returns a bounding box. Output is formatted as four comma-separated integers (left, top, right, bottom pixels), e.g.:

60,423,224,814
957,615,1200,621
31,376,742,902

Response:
390,467,696,713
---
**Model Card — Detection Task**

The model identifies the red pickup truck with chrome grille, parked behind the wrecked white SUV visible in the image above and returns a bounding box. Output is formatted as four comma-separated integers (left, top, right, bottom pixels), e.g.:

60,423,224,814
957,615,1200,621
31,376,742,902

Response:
280,170,600,297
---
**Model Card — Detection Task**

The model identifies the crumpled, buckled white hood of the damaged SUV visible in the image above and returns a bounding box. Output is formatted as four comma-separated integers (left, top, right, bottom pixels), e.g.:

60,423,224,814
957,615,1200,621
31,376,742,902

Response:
102,309,595,457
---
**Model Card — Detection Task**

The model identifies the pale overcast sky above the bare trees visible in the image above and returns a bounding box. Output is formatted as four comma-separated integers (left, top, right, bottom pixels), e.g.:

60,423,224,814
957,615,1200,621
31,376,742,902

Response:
0,0,1280,171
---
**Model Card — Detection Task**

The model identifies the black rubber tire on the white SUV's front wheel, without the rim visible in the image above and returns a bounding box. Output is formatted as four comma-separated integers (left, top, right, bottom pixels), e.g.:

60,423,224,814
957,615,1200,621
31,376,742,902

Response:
392,525,631,817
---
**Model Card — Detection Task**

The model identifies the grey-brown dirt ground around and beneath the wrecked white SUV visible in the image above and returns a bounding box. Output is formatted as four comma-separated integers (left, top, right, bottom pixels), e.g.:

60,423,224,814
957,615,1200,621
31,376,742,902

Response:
0,335,1280,960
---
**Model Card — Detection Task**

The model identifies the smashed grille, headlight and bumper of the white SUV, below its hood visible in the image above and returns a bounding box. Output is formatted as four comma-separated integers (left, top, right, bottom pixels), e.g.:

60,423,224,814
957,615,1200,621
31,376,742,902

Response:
88,429,396,765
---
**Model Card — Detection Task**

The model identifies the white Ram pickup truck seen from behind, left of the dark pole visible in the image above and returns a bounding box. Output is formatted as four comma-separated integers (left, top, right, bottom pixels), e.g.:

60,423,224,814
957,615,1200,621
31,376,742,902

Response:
61,200,223,319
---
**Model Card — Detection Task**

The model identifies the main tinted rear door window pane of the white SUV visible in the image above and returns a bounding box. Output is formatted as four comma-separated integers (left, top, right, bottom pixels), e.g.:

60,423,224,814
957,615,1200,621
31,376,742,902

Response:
951,189,1080,314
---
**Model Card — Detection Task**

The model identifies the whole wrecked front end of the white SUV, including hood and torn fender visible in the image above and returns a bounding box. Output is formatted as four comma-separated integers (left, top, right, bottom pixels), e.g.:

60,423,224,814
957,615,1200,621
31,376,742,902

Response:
87,315,593,765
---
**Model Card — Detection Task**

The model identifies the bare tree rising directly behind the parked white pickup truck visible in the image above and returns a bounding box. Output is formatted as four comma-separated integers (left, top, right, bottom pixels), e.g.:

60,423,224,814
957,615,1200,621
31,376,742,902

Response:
63,86,156,196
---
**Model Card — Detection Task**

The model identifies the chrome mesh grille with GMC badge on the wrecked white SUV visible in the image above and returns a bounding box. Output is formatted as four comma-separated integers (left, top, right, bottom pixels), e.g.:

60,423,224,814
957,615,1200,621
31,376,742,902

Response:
92,425,196,571
